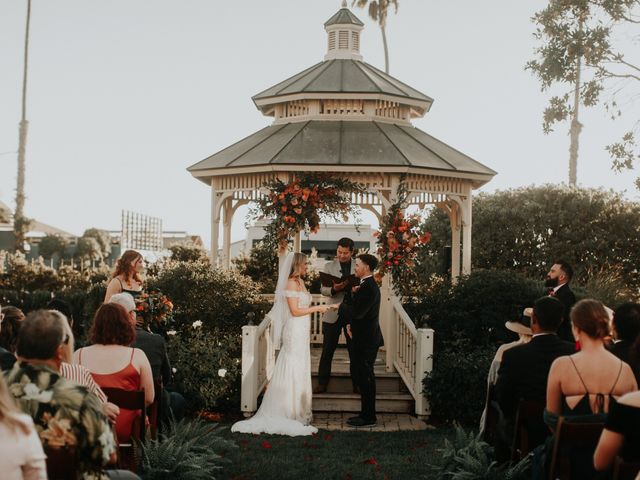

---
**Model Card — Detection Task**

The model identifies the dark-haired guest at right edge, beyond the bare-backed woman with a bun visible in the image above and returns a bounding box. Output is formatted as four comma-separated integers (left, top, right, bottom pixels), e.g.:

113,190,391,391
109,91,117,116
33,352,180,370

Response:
610,302,640,383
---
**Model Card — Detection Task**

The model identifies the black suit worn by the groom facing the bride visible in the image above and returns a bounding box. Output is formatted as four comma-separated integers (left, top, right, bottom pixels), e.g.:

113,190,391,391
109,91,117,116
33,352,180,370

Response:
340,277,382,421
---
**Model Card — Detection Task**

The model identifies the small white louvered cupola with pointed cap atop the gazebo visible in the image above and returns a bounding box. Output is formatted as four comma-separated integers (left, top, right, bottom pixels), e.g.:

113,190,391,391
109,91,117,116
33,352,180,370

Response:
324,1,364,60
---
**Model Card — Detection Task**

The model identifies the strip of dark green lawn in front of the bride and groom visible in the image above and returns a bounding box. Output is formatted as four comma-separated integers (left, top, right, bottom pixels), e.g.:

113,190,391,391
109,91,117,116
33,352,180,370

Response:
220,428,453,480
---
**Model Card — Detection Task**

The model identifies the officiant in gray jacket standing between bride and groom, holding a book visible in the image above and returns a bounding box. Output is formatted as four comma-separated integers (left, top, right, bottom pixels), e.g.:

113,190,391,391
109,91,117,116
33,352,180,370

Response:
313,237,357,393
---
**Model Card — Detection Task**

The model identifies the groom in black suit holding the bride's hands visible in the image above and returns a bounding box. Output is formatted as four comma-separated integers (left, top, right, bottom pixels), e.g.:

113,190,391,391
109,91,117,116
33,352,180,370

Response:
340,253,383,427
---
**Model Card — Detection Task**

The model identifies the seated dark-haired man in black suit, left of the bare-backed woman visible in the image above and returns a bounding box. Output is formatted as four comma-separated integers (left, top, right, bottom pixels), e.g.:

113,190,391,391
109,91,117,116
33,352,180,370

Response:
496,297,574,454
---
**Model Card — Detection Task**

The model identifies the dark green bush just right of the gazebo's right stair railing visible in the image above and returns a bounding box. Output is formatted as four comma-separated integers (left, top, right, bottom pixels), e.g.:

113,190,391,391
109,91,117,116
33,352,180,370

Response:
405,270,543,424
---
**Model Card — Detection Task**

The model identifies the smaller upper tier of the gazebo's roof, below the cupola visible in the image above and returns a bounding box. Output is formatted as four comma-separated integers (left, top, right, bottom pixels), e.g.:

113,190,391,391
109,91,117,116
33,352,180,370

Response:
252,59,433,111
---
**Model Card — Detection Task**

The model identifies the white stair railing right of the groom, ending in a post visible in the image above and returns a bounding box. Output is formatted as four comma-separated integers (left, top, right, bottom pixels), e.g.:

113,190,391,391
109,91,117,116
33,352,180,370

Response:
389,296,434,415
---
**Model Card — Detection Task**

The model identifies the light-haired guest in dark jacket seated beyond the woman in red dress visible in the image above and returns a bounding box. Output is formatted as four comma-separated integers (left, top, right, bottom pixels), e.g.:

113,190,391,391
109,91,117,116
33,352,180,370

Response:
109,293,185,420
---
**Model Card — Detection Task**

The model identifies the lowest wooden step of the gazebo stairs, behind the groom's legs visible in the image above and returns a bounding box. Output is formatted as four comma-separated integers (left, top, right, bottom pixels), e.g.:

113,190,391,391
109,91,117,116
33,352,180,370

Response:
313,393,414,413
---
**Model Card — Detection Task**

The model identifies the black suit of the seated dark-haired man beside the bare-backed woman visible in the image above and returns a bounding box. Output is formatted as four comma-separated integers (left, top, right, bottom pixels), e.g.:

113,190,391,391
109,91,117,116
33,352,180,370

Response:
496,334,575,446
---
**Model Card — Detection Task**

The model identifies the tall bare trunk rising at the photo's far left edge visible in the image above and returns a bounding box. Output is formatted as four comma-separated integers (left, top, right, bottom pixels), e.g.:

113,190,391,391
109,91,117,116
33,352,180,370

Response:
13,0,31,252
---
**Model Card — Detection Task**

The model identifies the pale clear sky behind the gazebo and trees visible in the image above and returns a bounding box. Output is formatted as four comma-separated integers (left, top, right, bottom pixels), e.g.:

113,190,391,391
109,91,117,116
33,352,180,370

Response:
0,0,640,245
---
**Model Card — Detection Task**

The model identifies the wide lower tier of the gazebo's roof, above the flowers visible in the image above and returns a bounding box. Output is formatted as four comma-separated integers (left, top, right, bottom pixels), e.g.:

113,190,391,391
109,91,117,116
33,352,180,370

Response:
188,120,496,185
